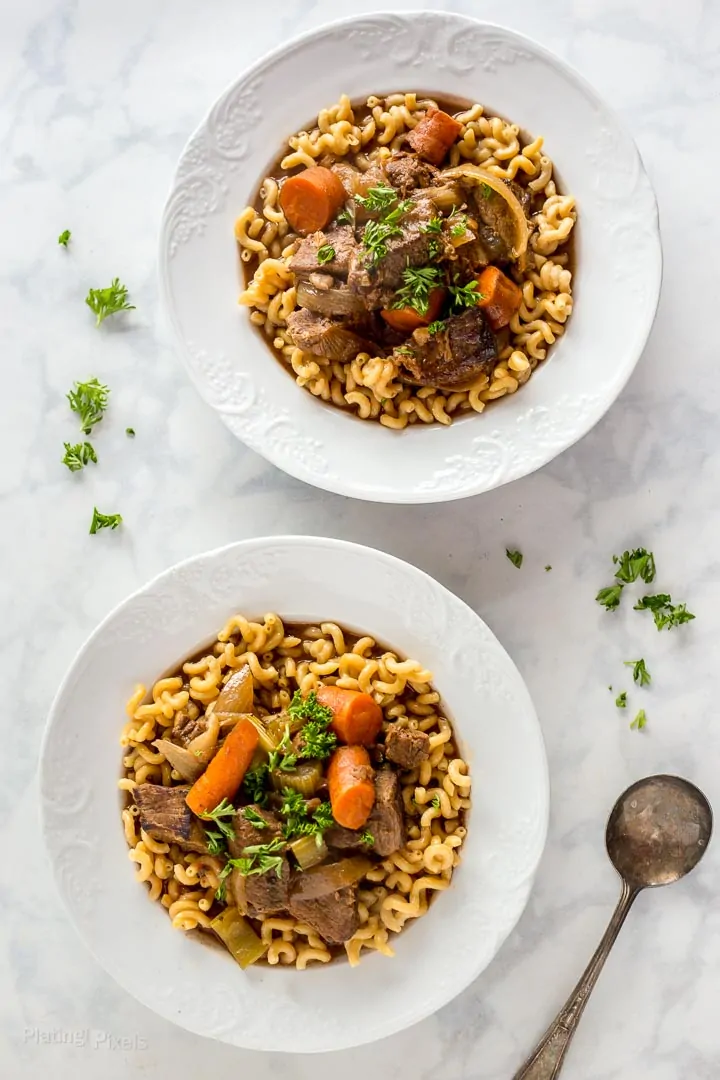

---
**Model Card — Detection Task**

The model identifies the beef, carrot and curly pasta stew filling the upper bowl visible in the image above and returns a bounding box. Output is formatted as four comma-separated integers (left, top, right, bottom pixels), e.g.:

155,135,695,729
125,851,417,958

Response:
235,93,575,429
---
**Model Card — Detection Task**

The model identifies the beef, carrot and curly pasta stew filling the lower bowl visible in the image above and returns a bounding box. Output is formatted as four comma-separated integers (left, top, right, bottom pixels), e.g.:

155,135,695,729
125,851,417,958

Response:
120,615,471,969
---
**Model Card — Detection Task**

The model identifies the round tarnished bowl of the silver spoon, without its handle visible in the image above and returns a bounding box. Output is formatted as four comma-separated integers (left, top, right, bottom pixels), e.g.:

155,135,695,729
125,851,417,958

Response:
606,775,712,889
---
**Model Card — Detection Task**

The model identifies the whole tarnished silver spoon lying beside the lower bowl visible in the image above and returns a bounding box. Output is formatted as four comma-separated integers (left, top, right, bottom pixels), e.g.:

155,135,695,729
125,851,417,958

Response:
514,775,712,1080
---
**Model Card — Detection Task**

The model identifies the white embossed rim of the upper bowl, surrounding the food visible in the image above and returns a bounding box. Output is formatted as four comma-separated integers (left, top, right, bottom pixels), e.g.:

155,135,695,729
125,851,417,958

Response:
160,12,662,502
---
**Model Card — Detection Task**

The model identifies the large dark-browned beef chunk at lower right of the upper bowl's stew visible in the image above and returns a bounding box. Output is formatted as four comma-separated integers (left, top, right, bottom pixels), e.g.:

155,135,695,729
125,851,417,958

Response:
394,308,498,390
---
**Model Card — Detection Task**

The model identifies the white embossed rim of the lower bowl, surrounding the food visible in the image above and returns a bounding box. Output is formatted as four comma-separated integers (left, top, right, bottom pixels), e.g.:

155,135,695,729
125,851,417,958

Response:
41,537,548,1052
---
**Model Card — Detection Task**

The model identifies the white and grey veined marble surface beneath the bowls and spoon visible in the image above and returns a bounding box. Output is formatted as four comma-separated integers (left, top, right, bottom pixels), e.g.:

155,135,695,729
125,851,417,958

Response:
0,0,720,1080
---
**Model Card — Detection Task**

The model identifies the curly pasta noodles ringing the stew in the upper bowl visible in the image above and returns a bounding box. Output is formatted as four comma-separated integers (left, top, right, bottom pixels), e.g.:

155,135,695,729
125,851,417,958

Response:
235,93,576,431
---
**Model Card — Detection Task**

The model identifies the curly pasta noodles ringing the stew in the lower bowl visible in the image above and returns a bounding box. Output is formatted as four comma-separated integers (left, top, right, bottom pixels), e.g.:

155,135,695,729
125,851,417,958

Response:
119,617,471,970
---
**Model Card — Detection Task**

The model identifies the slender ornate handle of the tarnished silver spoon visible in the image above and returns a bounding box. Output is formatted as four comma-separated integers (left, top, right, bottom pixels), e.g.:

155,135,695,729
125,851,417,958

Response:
513,882,639,1080
